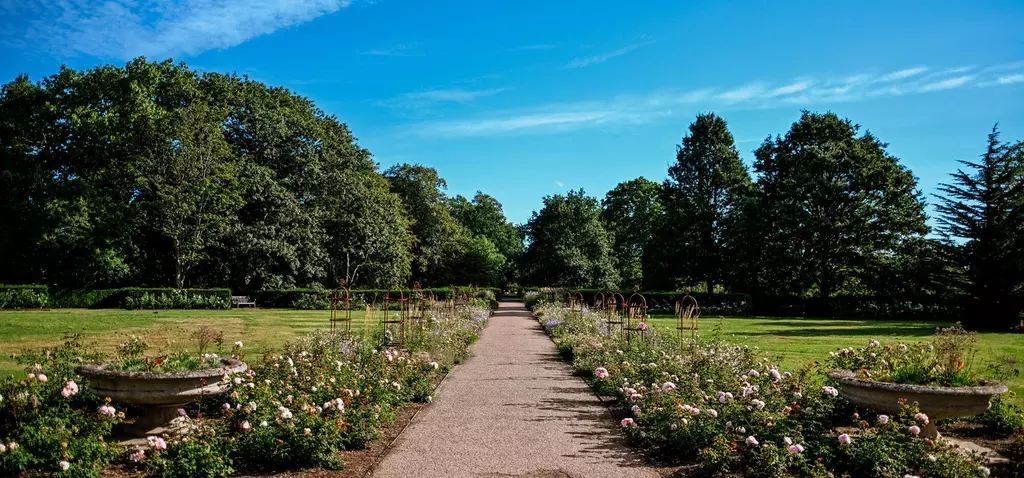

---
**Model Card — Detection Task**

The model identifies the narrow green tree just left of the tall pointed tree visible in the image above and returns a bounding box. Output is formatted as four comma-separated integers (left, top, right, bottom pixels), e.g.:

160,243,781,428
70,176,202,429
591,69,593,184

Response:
601,177,664,291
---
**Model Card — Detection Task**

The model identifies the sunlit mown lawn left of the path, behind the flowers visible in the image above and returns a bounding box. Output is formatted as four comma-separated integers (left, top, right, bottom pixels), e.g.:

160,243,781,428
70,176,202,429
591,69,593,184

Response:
0,309,399,377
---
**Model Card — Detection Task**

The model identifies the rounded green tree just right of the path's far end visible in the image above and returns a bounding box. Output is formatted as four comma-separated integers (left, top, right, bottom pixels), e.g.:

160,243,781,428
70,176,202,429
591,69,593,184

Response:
523,189,618,289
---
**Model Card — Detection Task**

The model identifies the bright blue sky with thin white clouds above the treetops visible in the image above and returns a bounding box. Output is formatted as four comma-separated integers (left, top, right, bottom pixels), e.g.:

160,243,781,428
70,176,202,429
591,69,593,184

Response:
0,0,1024,222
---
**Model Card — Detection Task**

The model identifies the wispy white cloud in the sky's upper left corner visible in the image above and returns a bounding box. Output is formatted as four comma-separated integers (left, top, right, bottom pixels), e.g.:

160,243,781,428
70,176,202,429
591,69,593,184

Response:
4,0,352,59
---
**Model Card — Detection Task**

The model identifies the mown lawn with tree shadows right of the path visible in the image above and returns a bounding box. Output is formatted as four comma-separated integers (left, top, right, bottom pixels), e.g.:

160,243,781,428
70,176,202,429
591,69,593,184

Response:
648,315,1024,405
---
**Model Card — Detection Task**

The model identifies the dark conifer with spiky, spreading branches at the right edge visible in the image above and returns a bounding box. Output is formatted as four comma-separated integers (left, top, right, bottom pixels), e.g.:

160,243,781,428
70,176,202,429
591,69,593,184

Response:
936,125,1024,329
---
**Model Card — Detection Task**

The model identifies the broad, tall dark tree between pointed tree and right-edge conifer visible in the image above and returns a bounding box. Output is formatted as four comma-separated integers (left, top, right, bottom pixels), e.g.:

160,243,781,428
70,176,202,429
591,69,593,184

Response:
754,112,928,298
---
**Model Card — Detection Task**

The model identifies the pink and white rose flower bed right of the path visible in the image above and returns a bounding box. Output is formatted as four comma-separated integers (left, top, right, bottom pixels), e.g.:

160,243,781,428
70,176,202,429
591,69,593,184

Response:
535,305,1007,477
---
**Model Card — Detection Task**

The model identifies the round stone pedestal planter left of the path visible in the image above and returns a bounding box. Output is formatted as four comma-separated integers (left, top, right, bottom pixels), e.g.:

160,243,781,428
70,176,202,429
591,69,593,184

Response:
77,358,248,437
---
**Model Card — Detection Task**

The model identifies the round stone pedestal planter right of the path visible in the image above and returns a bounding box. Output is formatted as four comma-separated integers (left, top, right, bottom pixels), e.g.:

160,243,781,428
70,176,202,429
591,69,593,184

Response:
828,371,1007,439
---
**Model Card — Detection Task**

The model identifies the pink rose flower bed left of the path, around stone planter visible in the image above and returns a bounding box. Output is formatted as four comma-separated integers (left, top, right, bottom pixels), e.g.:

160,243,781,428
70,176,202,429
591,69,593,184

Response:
0,304,489,477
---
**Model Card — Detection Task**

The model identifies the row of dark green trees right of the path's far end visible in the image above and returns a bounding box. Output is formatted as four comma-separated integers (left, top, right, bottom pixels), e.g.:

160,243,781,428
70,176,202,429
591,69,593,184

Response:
524,112,1024,329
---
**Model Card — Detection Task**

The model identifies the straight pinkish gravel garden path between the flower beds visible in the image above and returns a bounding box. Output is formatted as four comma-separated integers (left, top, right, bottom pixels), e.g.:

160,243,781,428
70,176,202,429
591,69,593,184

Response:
373,302,660,478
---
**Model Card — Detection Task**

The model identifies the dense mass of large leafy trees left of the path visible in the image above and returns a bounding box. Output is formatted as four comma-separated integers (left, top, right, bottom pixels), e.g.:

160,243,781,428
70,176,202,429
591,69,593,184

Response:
0,58,521,291
